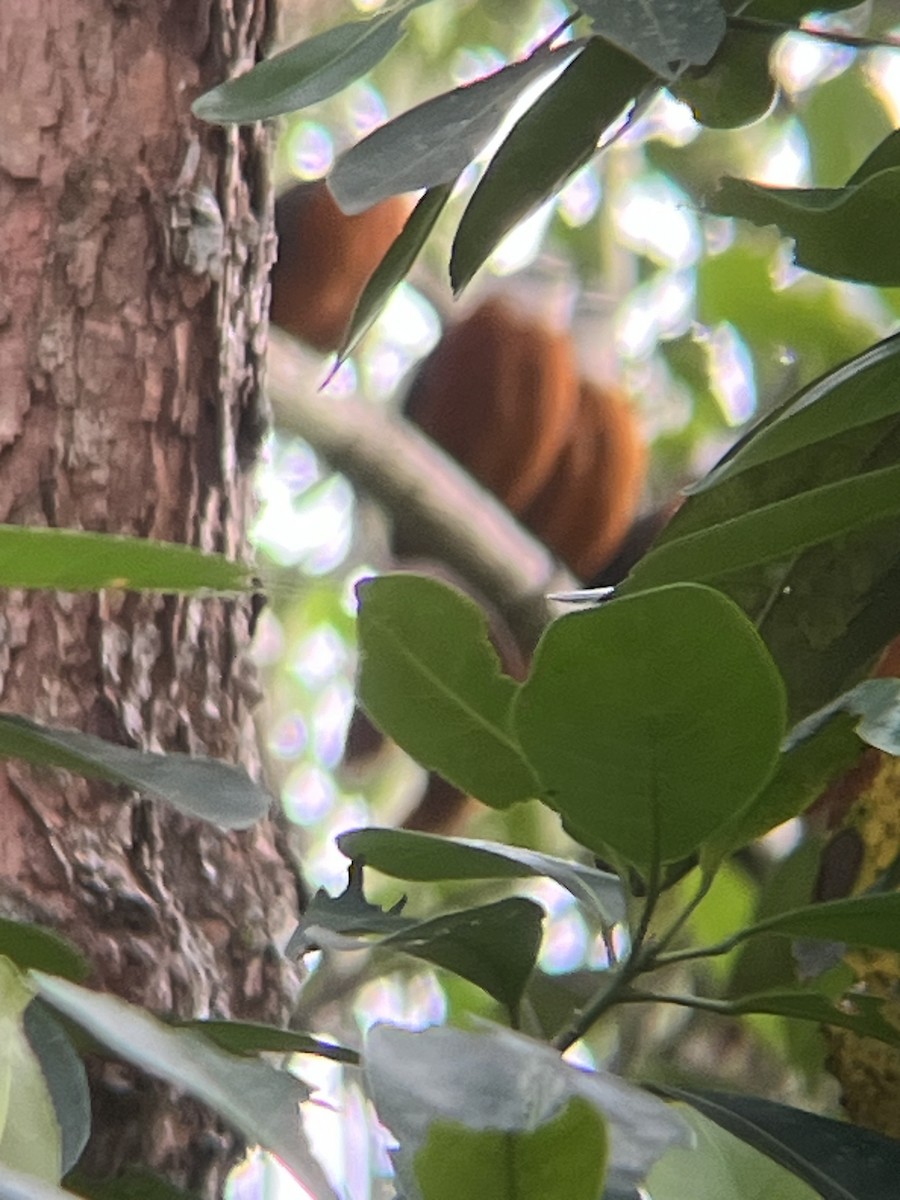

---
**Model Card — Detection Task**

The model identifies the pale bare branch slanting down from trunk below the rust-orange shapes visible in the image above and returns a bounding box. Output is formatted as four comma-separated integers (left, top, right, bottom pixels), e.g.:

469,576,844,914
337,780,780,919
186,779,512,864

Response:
268,330,577,649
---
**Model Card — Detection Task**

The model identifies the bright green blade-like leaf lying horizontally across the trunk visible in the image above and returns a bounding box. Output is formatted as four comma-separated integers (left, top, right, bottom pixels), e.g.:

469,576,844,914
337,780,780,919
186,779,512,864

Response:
0,526,256,593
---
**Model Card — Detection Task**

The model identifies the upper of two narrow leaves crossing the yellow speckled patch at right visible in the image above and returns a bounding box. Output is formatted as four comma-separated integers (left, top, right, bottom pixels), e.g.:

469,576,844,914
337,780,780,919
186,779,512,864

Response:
738,892,900,950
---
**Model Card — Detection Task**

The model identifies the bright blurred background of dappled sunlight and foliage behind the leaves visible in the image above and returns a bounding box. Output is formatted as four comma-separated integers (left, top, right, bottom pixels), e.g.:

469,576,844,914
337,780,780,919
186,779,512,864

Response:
232,0,900,1200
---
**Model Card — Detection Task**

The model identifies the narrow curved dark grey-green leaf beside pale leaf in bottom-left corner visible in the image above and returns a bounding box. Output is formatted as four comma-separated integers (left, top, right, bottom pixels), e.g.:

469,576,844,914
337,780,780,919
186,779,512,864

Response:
23,1000,91,1175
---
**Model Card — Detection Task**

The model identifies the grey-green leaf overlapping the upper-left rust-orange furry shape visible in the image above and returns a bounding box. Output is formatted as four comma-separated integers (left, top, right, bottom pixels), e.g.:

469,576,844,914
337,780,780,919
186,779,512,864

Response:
329,43,577,214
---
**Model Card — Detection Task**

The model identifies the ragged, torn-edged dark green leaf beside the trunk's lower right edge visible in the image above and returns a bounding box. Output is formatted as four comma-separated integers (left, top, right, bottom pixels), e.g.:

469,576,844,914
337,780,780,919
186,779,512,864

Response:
284,862,544,1015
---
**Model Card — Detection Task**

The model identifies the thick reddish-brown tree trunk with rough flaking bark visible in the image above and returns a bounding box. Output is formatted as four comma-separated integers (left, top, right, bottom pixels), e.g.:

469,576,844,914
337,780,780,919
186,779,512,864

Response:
0,0,303,1194
